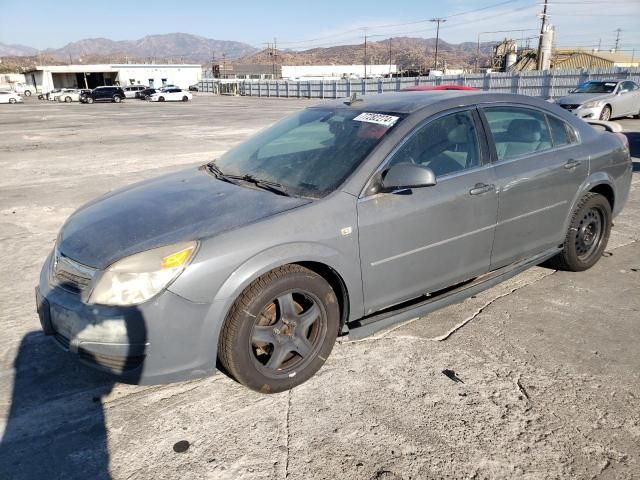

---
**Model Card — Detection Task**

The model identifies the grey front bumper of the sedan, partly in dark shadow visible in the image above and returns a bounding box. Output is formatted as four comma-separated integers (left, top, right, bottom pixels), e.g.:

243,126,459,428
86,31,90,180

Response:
36,255,217,384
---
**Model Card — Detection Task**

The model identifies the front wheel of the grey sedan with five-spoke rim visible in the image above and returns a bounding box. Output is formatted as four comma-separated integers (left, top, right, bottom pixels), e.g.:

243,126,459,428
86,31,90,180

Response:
218,265,340,393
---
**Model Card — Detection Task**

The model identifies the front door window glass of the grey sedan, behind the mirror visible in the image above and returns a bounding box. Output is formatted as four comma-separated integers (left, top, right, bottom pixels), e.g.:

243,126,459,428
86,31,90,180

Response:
388,111,480,177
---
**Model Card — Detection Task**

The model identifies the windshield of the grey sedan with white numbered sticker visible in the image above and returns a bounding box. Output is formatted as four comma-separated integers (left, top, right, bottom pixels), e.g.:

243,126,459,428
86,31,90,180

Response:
215,108,401,198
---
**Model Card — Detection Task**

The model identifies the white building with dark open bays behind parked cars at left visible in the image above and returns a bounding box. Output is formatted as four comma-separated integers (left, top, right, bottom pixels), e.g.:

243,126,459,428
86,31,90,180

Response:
24,64,202,92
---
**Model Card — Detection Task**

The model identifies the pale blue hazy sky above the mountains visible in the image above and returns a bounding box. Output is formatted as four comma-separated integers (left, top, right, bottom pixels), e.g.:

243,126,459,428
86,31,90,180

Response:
0,0,640,55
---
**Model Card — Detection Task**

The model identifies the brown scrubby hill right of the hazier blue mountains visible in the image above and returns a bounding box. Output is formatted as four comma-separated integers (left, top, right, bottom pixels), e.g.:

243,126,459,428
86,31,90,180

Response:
237,37,494,69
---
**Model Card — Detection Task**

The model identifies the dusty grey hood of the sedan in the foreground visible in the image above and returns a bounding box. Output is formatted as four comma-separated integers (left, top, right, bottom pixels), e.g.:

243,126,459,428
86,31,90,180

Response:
58,167,309,269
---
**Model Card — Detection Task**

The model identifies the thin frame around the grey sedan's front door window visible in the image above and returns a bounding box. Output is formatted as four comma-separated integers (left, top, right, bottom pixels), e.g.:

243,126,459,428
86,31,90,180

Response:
358,105,492,199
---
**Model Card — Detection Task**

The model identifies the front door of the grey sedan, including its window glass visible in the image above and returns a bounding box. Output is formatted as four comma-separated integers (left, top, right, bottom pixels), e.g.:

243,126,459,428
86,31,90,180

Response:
358,110,498,315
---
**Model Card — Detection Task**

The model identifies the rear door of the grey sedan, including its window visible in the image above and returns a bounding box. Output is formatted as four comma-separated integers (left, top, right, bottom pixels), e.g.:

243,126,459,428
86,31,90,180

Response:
481,105,589,270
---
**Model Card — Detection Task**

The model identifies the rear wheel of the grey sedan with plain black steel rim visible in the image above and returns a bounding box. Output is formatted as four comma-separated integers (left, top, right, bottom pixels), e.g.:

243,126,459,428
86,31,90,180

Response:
547,193,611,272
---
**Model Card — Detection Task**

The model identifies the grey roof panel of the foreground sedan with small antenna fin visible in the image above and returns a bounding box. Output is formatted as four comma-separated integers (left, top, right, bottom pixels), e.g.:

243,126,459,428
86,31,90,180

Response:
311,90,548,114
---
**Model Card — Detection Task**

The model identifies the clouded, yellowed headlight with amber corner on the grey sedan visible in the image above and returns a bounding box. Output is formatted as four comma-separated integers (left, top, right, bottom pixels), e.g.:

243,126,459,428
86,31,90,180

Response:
89,242,197,306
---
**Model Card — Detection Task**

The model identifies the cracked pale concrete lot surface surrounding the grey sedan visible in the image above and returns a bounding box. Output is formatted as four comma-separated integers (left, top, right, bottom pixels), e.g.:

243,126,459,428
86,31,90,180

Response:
0,96,640,480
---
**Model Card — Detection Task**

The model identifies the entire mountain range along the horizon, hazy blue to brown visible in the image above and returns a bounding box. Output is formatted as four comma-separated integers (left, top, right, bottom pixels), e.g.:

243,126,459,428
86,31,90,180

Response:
0,33,493,71
